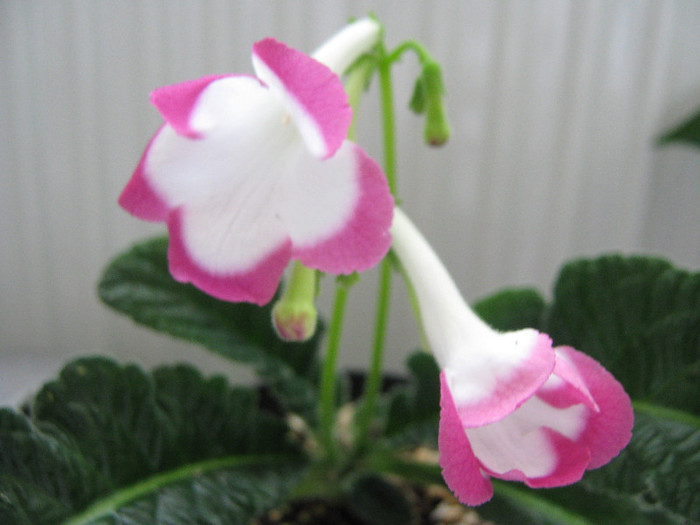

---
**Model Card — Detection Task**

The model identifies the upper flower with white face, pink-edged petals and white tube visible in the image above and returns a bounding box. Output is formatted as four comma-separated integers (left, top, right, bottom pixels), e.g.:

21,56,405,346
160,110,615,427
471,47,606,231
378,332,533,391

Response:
119,19,393,304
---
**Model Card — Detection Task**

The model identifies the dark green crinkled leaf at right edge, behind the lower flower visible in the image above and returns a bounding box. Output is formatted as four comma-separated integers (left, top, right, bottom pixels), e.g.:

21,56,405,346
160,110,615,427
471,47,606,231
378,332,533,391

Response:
544,256,700,414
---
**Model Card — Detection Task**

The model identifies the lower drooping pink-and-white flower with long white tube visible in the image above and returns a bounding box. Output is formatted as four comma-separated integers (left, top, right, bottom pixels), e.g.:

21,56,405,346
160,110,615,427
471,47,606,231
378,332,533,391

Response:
391,209,633,505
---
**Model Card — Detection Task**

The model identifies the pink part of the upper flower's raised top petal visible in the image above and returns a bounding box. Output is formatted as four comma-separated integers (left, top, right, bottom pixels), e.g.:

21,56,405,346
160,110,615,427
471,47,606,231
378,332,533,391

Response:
253,38,352,158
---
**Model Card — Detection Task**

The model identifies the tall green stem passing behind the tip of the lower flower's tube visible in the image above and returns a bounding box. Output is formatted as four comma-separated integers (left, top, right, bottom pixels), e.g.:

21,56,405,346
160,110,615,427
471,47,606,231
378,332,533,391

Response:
357,45,397,450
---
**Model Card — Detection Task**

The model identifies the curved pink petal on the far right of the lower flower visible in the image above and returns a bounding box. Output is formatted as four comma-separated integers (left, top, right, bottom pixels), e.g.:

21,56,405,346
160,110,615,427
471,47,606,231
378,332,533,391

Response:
557,347,634,469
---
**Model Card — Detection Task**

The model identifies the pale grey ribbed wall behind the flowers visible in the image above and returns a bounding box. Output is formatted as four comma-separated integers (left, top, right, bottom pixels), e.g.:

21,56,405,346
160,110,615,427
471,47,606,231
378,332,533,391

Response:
0,0,700,404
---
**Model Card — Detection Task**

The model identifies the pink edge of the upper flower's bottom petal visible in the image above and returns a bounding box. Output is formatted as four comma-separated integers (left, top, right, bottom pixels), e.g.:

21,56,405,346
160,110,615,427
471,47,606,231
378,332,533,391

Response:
168,209,291,306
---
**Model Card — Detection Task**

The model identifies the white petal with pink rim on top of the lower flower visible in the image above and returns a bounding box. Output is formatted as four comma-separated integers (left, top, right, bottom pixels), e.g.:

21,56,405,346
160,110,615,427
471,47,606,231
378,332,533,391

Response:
444,329,555,428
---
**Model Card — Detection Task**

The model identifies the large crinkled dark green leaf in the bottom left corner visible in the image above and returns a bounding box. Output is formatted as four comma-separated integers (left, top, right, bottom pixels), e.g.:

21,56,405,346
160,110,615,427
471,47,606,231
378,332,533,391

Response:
0,358,305,525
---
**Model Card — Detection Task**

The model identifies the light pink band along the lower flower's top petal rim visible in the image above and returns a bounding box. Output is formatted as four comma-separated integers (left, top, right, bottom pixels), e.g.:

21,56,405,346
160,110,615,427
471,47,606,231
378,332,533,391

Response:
456,333,555,428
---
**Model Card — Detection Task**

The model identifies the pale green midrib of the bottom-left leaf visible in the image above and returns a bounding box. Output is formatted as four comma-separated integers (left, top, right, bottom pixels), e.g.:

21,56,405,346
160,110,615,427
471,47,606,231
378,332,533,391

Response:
63,454,302,525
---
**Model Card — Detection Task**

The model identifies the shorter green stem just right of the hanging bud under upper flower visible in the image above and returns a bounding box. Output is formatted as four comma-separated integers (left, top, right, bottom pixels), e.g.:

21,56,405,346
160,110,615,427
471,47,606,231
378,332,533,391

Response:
319,283,348,462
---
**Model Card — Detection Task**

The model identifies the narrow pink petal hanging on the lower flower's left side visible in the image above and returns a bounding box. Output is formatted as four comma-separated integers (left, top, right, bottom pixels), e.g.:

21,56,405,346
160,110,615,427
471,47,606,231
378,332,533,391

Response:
438,374,493,505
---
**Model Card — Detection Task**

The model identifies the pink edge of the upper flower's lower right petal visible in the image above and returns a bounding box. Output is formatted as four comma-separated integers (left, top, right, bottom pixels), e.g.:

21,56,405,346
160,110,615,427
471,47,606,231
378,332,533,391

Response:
292,144,394,274
